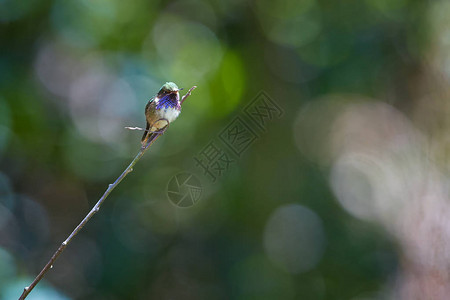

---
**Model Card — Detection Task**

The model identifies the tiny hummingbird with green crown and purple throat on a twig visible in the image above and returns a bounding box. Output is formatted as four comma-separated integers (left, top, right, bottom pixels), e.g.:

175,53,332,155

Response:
141,82,182,145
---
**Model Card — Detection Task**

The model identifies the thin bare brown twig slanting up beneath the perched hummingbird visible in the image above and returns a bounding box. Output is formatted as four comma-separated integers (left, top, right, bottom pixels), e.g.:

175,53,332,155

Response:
19,86,196,300
